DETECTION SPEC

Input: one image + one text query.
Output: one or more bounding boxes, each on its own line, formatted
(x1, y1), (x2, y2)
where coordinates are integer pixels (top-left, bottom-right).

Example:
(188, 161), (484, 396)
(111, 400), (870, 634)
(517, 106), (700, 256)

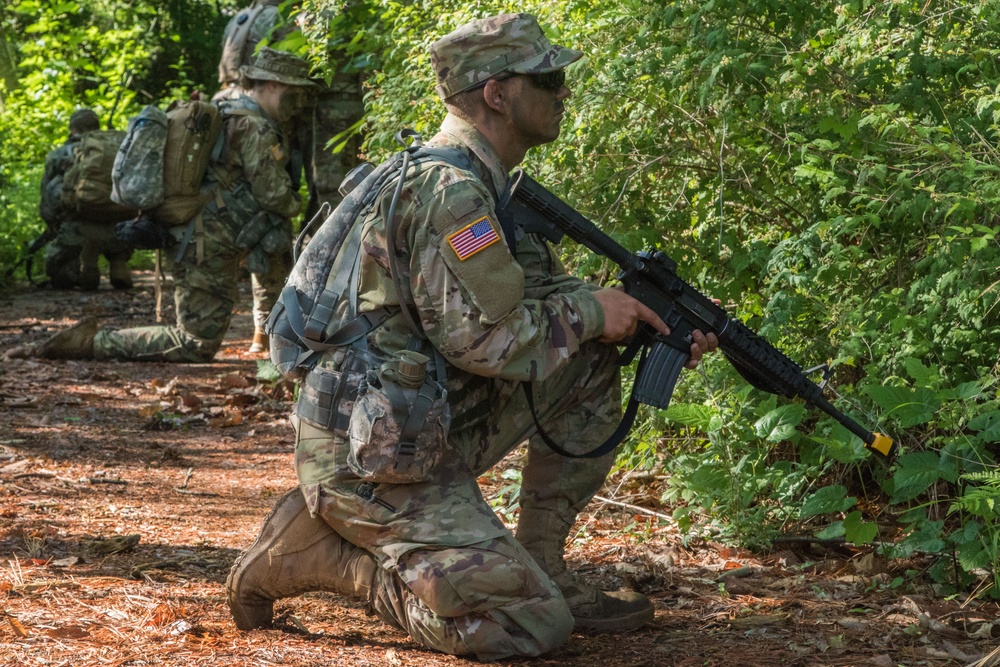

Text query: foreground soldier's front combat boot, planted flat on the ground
(517, 507), (653, 632)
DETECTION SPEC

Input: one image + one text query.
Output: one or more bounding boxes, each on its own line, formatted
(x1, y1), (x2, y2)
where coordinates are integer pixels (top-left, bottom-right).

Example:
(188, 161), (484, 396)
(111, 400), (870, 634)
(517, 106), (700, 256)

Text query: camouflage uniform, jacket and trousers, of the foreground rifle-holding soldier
(293, 15), (621, 660)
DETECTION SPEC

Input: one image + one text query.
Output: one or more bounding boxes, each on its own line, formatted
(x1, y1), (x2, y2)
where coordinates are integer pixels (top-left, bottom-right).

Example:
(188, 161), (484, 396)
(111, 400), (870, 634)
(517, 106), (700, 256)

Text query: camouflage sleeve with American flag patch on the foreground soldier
(410, 171), (604, 381)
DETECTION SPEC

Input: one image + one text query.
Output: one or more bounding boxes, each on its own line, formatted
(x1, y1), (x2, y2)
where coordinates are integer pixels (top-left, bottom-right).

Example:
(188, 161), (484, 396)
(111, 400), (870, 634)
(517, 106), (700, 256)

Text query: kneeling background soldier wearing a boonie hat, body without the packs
(39, 48), (314, 363)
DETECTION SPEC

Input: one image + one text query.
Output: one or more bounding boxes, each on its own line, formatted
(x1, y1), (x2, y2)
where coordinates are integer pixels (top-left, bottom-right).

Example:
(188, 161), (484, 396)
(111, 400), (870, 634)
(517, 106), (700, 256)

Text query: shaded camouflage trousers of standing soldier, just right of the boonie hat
(298, 74), (365, 220)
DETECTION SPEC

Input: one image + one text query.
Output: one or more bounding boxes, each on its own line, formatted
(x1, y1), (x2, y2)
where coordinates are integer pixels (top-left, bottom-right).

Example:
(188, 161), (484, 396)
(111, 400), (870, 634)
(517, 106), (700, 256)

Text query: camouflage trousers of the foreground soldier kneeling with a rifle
(293, 342), (621, 660)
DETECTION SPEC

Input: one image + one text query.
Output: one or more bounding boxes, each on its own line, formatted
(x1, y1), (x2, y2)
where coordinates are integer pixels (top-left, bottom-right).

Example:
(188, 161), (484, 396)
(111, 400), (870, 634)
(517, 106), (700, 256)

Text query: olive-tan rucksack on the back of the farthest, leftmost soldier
(62, 130), (136, 223)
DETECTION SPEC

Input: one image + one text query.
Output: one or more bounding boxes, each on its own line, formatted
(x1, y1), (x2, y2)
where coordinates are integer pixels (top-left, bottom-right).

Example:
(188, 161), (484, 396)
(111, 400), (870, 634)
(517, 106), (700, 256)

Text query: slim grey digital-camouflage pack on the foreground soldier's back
(264, 133), (471, 380)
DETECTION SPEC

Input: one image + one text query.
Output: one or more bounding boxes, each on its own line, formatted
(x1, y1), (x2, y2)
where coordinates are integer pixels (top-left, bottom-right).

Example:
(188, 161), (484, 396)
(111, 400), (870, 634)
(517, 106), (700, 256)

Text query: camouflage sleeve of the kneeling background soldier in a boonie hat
(234, 116), (302, 218)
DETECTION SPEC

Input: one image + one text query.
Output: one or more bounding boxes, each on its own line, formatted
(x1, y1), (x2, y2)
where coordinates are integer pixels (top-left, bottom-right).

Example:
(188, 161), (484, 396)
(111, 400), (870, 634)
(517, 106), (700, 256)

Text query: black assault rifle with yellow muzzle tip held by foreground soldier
(500, 170), (896, 460)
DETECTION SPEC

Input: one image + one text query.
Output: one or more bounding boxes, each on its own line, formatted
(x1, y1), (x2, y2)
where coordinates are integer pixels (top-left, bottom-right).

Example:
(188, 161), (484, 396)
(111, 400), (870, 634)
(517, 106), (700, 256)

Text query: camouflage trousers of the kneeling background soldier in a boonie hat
(94, 211), (244, 363)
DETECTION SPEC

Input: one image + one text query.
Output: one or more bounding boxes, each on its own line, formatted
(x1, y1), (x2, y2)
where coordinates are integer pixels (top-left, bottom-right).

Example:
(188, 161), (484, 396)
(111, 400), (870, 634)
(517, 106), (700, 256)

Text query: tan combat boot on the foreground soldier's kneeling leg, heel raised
(226, 488), (377, 630)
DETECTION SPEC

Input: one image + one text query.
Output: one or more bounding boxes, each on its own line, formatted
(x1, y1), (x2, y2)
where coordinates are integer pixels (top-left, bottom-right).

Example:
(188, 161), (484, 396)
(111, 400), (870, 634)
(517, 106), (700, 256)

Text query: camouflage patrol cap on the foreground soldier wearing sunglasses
(431, 13), (583, 100)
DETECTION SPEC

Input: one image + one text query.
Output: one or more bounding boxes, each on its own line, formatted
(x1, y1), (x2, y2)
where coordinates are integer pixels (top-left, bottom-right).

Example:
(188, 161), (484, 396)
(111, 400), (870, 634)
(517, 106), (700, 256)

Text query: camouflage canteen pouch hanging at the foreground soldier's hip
(347, 358), (451, 484)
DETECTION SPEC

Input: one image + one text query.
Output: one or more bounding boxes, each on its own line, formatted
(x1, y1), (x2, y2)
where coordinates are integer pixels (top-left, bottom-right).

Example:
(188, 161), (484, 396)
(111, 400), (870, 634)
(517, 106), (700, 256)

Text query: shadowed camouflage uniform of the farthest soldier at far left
(39, 109), (132, 289)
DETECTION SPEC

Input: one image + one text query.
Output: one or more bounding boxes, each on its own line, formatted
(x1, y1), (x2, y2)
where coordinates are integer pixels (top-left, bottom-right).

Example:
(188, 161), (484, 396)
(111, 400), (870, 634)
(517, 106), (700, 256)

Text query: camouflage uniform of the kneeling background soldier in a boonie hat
(94, 91), (301, 363)
